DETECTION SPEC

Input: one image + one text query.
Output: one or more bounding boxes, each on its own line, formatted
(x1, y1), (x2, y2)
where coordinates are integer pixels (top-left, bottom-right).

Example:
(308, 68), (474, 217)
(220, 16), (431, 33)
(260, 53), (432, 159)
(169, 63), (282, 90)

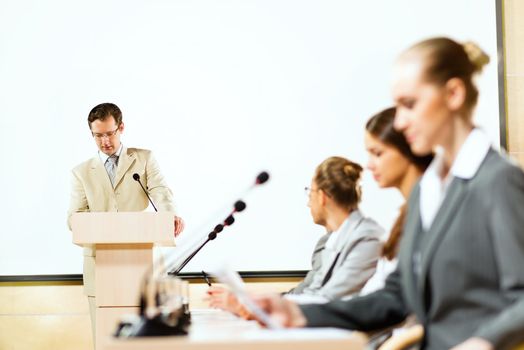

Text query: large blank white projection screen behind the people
(0, 0), (502, 277)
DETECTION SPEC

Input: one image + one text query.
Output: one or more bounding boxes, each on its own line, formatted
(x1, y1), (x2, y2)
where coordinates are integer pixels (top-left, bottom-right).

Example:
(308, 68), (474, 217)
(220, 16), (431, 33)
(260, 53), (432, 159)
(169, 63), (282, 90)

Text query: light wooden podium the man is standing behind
(71, 212), (175, 349)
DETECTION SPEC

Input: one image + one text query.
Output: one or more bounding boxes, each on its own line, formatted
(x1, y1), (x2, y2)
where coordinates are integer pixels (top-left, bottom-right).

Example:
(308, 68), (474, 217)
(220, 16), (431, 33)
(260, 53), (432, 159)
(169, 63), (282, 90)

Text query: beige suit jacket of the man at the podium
(68, 147), (175, 296)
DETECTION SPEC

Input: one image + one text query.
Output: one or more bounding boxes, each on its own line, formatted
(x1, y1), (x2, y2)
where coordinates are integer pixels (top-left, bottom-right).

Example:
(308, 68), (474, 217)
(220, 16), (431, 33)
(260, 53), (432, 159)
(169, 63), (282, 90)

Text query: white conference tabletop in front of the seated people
(98, 309), (367, 350)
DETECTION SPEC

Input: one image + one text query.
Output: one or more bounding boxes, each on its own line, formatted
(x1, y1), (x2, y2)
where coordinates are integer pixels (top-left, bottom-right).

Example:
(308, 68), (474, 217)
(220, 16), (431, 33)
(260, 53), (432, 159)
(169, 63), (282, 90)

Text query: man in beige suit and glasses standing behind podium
(68, 103), (184, 342)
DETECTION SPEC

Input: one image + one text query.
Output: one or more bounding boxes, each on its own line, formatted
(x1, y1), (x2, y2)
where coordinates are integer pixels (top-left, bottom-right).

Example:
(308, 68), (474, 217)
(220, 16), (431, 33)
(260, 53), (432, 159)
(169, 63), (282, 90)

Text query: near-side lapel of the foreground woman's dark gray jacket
(419, 177), (467, 295)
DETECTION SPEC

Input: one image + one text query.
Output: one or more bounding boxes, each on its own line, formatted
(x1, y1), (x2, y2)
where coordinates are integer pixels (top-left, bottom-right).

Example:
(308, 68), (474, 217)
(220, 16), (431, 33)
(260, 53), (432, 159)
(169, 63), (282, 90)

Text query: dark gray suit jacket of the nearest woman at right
(302, 150), (524, 349)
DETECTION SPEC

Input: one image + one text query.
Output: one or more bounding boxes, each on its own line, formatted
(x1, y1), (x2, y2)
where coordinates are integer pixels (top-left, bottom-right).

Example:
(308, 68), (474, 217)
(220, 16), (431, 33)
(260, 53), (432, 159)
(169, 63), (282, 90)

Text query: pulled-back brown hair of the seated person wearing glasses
(313, 157), (362, 210)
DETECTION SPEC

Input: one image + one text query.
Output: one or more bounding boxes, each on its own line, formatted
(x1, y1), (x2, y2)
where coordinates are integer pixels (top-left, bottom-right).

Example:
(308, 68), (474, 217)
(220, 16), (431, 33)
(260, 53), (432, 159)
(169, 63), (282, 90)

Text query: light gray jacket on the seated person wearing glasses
(291, 210), (384, 299)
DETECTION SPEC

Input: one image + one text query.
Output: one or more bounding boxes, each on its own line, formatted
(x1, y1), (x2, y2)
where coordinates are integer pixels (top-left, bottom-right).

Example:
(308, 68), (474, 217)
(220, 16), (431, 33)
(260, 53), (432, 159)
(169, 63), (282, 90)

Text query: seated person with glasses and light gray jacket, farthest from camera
(208, 157), (384, 317)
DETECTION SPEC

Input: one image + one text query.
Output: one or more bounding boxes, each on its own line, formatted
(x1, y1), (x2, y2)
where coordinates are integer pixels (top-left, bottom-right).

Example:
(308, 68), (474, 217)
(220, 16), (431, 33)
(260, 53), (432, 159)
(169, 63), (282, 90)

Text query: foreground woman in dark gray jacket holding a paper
(260, 38), (524, 350)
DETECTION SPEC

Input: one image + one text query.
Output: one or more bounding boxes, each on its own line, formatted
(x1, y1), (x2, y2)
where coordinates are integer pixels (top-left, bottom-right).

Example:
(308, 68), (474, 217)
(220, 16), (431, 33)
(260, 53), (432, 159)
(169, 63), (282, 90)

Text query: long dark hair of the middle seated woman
(366, 107), (433, 260)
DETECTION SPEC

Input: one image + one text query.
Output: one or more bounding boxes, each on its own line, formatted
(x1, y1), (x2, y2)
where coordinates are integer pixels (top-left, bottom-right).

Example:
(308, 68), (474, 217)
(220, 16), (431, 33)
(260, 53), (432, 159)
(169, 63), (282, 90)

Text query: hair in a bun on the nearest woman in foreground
(401, 38), (489, 109)
